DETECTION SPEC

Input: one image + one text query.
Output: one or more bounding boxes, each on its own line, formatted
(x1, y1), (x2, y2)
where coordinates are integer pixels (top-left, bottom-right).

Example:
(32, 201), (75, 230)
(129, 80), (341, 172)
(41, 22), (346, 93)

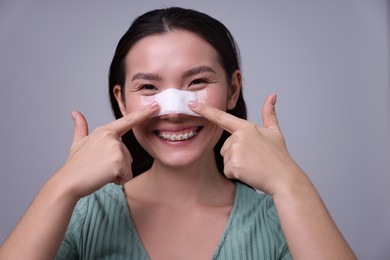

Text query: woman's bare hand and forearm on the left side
(0, 103), (158, 260)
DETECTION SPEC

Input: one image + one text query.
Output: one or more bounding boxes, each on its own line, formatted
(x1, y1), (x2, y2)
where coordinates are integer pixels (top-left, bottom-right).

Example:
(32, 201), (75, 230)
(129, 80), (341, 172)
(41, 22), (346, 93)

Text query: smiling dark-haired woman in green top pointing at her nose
(0, 8), (355, 259)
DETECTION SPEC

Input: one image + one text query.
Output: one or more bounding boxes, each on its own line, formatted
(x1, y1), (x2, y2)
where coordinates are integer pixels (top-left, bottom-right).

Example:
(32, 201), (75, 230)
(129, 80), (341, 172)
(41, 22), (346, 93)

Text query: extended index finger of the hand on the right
(189, 103), (246, 134)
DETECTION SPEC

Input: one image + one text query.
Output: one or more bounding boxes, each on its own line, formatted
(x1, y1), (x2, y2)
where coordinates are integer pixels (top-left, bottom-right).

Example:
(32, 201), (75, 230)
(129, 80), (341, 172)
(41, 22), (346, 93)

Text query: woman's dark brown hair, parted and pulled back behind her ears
(109, 7), (247, 176)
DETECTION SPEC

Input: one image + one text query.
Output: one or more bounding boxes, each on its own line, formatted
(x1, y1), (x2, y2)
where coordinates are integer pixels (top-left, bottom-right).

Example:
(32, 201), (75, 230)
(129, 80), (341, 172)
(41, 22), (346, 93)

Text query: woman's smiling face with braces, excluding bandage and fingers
(114, 30), (241, 167)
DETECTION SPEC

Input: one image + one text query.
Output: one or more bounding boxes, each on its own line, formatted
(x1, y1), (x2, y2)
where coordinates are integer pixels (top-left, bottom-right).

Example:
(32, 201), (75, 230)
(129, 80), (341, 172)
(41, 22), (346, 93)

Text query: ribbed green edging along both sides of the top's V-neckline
(121, 182), (240, 259)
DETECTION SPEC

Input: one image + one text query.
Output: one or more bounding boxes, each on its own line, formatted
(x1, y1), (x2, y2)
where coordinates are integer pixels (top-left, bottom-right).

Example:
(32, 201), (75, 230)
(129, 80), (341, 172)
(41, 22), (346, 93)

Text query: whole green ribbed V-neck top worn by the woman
(56, 182), (291, 260)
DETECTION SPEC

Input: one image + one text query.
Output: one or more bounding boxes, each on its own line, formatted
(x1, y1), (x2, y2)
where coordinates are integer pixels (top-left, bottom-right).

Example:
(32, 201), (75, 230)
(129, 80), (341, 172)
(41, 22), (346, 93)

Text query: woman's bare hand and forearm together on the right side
(189, 95), (356, 259)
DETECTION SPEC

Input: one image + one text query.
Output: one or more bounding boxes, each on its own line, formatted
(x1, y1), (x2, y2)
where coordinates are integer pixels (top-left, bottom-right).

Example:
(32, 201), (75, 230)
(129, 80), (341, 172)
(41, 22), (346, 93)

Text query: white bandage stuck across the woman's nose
(141, 88), (207, 116)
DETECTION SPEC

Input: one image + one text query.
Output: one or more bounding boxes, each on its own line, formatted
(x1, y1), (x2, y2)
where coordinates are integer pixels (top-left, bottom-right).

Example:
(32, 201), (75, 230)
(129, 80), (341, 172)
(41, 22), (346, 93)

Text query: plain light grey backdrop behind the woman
(0, 0), (390, 259)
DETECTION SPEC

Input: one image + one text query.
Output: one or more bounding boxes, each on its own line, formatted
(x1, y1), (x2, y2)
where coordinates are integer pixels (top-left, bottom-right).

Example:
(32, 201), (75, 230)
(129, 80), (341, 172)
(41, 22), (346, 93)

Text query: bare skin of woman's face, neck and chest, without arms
(114, 31), (241, 259)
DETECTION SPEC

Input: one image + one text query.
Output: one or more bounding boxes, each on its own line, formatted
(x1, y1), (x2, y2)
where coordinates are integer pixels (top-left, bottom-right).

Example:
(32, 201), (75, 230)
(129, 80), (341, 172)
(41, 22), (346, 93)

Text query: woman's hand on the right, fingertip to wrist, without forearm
(190, 95), (300, 194)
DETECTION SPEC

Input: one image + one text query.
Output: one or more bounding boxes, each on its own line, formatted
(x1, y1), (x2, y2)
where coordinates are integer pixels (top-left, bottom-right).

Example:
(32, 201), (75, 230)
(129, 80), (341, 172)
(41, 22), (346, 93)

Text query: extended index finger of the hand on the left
(106, 102), (158, 136)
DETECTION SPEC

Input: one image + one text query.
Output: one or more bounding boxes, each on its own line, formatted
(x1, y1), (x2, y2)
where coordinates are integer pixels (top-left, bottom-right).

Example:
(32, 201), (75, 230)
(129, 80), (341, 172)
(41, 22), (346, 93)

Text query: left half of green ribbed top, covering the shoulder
(58, 184), (145, 259)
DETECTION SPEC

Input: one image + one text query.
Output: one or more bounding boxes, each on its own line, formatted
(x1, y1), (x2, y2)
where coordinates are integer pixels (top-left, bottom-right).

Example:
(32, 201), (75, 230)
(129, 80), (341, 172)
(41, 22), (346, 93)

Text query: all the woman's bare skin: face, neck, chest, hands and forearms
(0, 31), (355, 259)
